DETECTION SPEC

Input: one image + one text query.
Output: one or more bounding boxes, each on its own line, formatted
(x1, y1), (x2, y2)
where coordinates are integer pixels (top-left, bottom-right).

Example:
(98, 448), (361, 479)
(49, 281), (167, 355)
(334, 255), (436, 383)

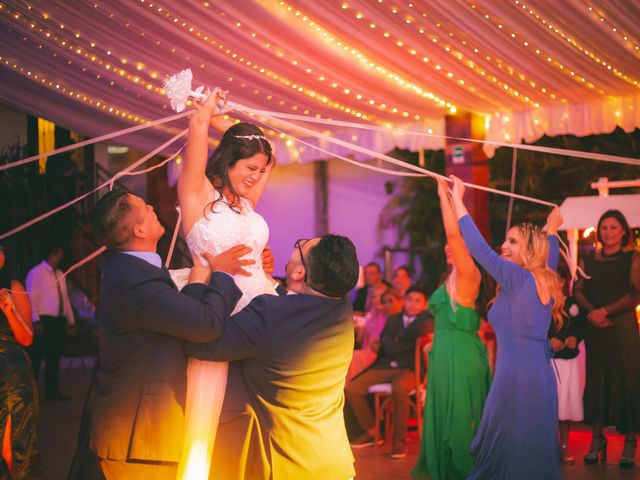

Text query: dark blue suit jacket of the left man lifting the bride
(90, 253), (242, 462)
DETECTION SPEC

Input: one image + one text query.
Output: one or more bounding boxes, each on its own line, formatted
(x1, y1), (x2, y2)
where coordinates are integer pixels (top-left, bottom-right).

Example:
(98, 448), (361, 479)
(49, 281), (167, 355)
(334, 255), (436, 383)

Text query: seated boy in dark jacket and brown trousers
(345, 287), (433, 459)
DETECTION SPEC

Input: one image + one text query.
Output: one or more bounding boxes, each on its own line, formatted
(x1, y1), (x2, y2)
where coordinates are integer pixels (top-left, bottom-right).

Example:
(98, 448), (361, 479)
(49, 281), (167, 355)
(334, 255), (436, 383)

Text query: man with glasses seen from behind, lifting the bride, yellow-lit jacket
(188, 235), (358, 480)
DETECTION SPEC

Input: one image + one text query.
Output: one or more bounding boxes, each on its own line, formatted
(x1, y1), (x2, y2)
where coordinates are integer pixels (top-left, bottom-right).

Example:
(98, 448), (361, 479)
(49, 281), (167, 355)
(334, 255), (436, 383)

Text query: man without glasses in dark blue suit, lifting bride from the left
(90, 191), (250, 480)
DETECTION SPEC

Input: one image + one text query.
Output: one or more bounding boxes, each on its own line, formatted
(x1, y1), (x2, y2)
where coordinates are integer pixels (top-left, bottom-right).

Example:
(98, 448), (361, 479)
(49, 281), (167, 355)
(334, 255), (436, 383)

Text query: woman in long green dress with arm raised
(411, 179), (491, 480)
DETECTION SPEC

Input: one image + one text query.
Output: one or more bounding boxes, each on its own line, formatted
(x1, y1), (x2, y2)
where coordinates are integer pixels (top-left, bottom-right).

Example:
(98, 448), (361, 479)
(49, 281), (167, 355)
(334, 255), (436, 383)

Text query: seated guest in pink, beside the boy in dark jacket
(347, 283), (389, 385)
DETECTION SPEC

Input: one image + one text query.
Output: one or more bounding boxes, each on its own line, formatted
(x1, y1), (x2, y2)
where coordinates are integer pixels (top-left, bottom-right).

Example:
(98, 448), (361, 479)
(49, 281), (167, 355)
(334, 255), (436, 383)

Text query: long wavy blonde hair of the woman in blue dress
(514, 223), (566, 329)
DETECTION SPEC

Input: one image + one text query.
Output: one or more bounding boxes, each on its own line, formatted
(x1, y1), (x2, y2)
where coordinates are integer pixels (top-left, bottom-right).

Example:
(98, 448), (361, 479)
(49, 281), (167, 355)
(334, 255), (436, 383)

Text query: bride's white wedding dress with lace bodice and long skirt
(172, 197), (276, 480)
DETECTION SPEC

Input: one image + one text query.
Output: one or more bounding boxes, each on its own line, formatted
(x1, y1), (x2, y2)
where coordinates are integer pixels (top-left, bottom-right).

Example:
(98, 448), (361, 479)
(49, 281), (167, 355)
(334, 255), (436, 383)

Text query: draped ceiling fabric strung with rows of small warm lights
(0, 0), (640, 163)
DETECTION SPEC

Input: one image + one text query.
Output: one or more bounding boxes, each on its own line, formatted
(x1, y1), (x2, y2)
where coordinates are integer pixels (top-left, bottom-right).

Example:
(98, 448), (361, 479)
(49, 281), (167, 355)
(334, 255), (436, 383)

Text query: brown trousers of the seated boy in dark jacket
(345, 368), (416, 443)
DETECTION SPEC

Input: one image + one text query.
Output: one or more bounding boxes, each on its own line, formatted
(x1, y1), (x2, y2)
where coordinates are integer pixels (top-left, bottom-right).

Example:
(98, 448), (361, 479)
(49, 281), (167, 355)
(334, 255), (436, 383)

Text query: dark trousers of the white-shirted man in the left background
(28, 315), (67, 395)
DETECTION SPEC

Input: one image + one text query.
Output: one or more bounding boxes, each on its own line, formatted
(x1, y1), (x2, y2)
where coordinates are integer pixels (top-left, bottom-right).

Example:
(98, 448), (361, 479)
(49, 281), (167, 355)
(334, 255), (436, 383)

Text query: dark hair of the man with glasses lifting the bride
(307, 235), (360, 298)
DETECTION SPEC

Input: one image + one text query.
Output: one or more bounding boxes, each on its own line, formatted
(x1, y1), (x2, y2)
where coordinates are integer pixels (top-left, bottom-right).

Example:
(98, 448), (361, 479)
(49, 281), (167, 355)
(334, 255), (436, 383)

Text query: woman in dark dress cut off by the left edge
(0, 247), (43, 480)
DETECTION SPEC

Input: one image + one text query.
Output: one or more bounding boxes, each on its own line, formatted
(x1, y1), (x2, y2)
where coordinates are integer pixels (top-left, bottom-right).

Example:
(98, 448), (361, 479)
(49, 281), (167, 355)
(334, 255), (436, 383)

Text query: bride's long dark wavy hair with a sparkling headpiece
(205, 122), (276, 215)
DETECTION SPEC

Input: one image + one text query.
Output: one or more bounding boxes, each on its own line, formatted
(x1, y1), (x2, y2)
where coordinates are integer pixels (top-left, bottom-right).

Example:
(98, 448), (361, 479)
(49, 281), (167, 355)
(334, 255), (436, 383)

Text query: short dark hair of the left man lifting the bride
(91, 190), (131, 250)
